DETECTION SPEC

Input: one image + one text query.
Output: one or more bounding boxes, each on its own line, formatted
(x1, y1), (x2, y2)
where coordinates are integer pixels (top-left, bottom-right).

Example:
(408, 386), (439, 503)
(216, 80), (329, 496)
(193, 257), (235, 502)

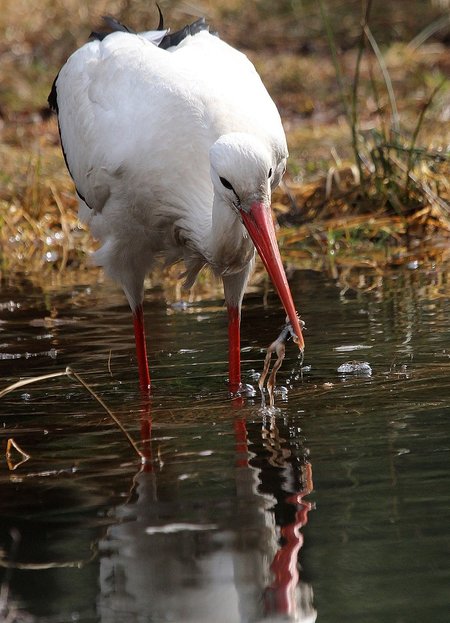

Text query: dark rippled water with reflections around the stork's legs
(0, 270), (450, 623)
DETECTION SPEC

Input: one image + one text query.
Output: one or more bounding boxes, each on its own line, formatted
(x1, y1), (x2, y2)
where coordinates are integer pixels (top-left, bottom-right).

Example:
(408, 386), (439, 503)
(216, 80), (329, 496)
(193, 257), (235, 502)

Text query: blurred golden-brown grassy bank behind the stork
(0, 0), (450, 286)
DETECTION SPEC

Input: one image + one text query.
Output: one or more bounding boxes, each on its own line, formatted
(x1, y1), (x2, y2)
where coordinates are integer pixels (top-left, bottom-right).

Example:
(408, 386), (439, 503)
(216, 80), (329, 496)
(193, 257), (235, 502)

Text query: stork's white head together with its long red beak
(210, 132), (304, 350)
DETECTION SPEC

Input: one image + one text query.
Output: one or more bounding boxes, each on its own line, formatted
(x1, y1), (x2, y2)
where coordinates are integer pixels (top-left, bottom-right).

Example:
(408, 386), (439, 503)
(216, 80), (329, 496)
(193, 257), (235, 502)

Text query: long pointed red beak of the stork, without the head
(241, 201), (305, 351)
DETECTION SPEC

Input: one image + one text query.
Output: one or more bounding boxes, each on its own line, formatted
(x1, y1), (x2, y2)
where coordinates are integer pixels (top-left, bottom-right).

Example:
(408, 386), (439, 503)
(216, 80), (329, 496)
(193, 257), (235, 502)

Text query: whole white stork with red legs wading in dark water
(49, 12), (304, 393)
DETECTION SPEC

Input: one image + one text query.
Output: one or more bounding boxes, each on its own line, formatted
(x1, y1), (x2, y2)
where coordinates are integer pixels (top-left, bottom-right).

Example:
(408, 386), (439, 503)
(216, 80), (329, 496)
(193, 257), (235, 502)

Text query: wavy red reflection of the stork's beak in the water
(265, 463), (313, 615)
